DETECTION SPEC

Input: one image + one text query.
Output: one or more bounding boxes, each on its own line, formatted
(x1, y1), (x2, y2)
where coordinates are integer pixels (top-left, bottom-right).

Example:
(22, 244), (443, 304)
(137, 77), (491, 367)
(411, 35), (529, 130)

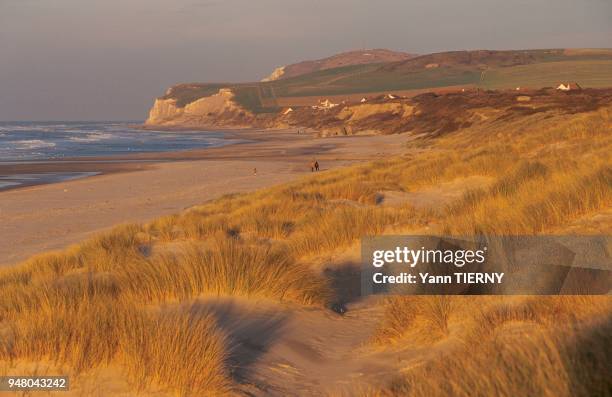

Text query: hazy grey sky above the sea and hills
(0, 0), (612, 120)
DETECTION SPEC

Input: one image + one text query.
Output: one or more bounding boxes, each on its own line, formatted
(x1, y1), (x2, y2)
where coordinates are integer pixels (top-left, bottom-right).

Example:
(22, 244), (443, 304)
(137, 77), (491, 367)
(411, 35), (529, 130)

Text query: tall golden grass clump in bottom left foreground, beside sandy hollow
(0, 273), (232, 395)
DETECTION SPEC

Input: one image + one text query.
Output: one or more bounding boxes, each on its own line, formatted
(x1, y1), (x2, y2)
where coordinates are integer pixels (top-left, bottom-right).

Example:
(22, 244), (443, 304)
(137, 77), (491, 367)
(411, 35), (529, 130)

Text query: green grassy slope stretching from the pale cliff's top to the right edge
(165, 50), (612, 113)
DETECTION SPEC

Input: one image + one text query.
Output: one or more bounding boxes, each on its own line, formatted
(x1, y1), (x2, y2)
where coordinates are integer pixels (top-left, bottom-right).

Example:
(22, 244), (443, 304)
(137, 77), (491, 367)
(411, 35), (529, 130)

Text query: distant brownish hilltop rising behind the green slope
(262, 48), (414, 81)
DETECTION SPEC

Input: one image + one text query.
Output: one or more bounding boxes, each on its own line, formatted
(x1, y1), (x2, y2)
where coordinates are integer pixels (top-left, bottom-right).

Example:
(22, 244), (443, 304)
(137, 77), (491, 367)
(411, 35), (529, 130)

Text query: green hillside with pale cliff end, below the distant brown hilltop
(147, 49), (612, 126)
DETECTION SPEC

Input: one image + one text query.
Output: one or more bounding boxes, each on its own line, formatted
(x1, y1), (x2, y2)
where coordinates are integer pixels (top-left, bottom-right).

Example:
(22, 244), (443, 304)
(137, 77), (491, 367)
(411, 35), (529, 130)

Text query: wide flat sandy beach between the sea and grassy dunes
(0, 131), (409, 266)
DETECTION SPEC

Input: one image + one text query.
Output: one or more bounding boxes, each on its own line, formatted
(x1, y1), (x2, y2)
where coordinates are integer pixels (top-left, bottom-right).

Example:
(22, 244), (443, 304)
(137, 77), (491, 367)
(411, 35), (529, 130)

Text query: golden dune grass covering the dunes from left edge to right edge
(0, 95), (612, 396)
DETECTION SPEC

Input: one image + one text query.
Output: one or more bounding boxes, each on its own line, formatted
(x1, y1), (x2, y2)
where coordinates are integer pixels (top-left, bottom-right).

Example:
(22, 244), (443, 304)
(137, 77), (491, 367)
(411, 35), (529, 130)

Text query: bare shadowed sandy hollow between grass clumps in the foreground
(194, 297), (414, 396)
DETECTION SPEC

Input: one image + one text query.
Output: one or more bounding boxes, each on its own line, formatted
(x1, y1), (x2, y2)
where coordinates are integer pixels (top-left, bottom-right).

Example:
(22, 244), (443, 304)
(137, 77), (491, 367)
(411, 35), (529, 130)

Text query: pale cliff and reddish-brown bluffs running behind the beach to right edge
(146, 83), (612, 136)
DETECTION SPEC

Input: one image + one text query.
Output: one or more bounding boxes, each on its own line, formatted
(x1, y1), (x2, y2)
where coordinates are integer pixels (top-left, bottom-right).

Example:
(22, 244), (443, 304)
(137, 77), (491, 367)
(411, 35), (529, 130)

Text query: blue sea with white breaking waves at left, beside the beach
(0, 121), (235, 190)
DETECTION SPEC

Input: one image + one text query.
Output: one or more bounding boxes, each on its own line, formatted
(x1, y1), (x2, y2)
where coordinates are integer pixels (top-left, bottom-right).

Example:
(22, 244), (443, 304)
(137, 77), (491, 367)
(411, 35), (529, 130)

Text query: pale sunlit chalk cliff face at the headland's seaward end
(145, 88), (255, 128)
